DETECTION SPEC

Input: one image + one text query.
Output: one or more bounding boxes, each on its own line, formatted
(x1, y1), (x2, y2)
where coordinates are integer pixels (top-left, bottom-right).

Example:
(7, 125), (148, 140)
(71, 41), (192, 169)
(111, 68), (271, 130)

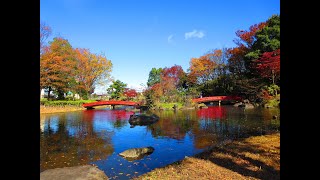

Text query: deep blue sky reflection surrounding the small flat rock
(93, 126), (201, 178)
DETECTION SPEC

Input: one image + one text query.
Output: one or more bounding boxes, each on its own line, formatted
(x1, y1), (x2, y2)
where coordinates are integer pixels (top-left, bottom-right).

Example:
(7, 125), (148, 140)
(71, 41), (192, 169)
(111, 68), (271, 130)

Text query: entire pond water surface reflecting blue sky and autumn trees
(40, 106), (280, 179)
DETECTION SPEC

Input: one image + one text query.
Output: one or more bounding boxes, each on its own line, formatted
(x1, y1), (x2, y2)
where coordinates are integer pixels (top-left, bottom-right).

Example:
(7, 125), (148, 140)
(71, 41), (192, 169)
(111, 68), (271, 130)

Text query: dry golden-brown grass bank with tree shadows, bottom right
(135, 133), (280, 179)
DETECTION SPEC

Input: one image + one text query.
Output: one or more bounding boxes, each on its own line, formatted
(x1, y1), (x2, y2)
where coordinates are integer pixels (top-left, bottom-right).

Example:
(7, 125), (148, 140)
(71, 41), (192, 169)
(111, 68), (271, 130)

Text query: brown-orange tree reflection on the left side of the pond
(40, 112), (114, 171)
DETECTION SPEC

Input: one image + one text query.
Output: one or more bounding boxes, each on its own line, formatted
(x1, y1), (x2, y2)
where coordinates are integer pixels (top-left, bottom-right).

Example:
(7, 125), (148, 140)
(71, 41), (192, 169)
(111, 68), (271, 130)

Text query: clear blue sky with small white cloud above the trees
(40, 0), (280, 93)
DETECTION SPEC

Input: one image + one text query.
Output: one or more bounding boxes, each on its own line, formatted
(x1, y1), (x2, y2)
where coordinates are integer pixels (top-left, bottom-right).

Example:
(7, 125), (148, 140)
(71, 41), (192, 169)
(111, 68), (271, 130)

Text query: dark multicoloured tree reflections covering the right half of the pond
(147, 106), (279, 149)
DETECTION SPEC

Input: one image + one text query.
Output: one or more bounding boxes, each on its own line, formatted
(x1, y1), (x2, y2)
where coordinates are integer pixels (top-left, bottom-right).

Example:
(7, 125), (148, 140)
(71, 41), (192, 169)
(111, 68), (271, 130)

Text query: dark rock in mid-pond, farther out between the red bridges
(129, 114), (159, 126)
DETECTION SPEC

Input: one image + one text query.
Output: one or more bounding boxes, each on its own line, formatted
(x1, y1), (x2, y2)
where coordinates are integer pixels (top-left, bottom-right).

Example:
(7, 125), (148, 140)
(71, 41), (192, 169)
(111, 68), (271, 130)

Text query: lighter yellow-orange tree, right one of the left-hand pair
(74, 48), (112, 97)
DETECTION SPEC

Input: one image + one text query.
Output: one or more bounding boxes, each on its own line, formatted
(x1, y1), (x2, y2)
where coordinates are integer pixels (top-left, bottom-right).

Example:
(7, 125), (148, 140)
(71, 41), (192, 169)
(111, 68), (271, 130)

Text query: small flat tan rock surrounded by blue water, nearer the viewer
(119, 146), (154, 160)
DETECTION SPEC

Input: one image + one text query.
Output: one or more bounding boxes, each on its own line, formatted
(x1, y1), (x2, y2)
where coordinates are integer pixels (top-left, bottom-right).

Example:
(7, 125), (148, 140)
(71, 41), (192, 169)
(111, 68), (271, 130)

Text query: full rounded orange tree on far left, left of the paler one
(40, 37), (76, 99)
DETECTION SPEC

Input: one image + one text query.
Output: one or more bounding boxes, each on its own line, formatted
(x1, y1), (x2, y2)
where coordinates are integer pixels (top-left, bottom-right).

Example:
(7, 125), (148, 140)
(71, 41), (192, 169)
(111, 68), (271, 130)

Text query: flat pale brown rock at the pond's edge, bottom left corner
(40, 165), (109, 180)
